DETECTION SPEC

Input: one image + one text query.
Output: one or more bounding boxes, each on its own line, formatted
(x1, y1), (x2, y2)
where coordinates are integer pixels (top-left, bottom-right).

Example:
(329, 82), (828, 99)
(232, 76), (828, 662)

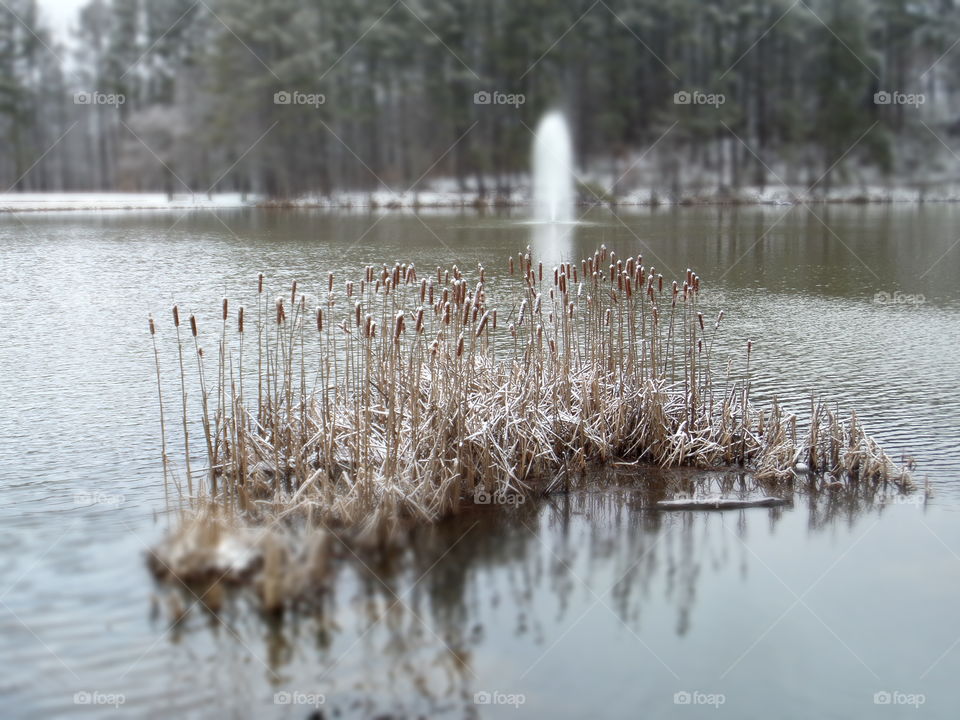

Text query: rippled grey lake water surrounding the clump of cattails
(0, 204), (960, 719)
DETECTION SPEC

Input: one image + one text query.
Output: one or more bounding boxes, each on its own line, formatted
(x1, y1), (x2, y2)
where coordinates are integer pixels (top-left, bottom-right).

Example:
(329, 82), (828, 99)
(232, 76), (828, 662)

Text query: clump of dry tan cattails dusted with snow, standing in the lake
(148, 247), (910, 580)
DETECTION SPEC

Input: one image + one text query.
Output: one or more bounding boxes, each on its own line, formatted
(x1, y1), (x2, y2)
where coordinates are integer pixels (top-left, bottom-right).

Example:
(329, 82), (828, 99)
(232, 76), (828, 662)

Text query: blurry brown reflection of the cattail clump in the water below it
(154, 471), (922, 717)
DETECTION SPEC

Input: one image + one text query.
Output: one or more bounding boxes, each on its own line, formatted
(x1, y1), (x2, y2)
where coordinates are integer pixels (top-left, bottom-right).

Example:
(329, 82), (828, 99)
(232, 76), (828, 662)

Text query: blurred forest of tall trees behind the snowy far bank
(0, 0), (960, 198)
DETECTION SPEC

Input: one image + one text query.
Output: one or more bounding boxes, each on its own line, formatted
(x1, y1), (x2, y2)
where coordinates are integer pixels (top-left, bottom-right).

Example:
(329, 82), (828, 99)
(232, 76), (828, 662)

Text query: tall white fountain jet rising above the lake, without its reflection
(533, 110), (573, 223)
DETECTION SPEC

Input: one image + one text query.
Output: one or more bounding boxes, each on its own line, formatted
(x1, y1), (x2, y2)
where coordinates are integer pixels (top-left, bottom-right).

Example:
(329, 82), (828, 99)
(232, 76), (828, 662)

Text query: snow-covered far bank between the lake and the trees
(0, 184), (960, 213)
